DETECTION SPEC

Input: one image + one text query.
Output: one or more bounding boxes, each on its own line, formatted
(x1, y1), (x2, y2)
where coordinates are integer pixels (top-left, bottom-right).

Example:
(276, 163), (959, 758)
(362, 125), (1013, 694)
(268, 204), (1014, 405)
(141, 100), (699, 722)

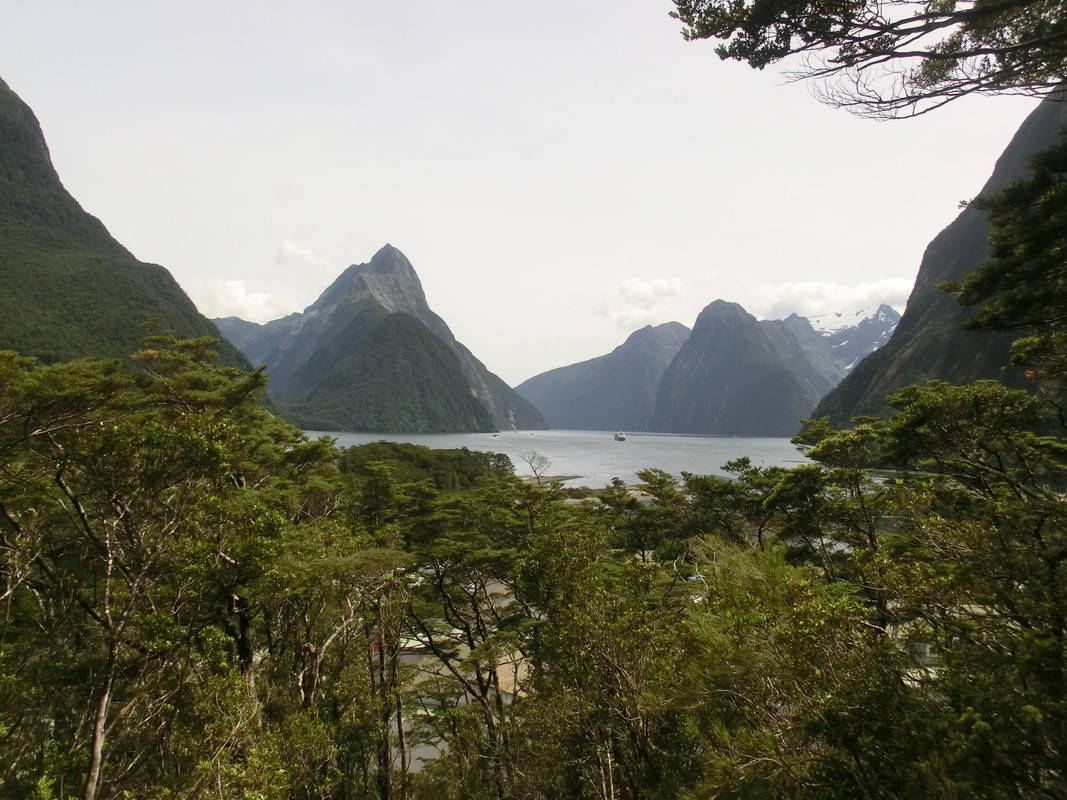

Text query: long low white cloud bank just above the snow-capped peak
(742, 278), (914, 319)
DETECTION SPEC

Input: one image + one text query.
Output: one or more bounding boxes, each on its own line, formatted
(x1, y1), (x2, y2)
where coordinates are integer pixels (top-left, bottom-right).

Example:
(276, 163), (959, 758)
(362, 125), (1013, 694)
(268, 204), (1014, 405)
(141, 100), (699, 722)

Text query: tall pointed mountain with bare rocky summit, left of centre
(216, 244), (546, 432)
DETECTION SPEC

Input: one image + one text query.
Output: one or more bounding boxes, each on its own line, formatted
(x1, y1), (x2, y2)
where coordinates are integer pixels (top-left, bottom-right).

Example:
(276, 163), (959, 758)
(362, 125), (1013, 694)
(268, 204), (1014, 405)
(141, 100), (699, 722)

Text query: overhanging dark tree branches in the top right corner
(672, 0), (1067, 117)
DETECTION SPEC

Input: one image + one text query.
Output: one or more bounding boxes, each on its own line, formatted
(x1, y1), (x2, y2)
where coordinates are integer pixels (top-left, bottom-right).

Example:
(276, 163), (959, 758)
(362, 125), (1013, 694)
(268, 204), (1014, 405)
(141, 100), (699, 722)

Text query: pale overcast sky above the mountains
(0, 0), (1037, 386)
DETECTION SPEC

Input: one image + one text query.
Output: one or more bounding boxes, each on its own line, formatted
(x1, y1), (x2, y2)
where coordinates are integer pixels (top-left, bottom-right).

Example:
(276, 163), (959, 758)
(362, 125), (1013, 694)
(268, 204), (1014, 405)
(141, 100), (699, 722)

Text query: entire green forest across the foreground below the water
(6, 332), (1067, 800)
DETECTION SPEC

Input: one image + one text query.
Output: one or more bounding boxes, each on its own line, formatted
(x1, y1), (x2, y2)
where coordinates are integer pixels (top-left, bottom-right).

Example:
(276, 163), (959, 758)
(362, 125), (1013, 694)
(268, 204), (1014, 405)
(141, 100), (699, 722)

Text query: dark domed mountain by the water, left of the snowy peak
(649, 300), (843, 436)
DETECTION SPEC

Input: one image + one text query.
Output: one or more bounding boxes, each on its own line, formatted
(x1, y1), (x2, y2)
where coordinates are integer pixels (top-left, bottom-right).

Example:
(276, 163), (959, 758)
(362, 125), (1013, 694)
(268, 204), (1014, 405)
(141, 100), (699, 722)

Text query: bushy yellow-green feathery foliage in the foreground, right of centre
(688, 543), (921, 798)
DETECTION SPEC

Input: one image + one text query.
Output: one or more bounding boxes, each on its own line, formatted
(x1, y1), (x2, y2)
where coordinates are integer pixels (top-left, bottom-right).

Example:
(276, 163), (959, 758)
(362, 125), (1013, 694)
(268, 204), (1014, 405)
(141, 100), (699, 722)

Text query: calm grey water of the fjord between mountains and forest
(307, 431), (805, 489)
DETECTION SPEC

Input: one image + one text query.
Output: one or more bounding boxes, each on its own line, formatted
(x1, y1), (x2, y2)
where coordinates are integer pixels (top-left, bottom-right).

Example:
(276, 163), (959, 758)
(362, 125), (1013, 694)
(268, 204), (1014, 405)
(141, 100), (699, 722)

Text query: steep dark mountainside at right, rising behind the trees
(814, 93), (1067, 426)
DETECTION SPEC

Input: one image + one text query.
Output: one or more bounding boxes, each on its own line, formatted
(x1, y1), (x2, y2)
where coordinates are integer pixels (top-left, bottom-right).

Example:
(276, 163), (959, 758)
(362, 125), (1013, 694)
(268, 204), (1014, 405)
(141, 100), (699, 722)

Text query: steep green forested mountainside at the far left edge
(0, 73), (248, 367)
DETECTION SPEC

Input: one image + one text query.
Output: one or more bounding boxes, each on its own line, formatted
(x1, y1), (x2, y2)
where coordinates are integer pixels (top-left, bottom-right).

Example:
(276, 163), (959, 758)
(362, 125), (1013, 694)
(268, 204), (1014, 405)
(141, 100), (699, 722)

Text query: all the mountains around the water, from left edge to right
(0, 66), (1067, 436)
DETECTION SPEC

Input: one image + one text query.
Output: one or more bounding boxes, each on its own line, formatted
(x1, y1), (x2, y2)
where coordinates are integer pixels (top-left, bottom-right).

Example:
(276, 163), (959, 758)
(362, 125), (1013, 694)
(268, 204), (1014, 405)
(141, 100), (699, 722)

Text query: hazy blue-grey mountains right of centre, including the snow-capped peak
(516, 300), (901, 436)
